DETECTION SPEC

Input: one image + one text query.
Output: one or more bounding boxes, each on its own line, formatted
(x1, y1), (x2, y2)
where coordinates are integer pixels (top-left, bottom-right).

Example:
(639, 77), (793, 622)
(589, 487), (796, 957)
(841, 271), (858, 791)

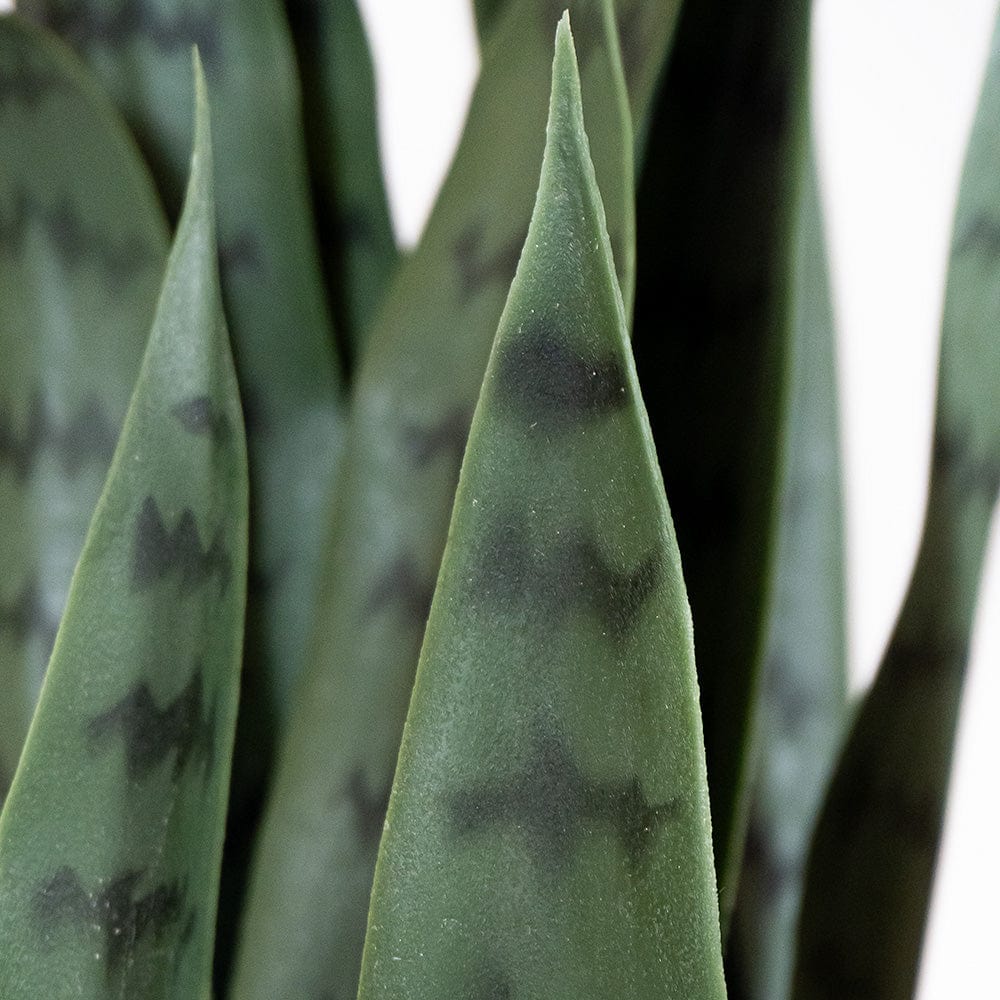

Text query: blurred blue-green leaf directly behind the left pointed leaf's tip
(18, 0), (342, 740)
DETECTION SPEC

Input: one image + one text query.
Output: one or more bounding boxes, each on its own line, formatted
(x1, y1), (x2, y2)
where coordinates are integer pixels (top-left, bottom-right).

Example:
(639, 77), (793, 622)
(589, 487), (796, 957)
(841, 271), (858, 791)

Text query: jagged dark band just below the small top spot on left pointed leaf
(132, 496), (232, 590)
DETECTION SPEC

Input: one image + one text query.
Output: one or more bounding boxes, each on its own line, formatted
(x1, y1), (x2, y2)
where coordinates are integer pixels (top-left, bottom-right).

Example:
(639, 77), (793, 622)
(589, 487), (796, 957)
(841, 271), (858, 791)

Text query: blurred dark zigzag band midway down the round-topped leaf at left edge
(0, 391), (118, 482)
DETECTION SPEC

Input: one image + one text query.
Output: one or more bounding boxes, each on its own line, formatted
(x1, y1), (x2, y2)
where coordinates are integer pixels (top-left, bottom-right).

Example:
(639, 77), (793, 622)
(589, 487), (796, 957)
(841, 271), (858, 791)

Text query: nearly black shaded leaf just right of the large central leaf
(635, 0), (810, 920)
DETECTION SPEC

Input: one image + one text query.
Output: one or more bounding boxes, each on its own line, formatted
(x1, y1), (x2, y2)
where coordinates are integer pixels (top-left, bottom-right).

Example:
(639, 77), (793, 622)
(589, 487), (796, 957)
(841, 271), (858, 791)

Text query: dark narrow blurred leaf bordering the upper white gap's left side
(285, 0), (399, 357)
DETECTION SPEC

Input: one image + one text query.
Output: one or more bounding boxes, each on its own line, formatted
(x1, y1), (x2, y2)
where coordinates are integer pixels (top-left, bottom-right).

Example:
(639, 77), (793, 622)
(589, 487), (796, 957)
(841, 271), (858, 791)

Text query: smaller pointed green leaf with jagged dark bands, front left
(0, 58), (247, 1000)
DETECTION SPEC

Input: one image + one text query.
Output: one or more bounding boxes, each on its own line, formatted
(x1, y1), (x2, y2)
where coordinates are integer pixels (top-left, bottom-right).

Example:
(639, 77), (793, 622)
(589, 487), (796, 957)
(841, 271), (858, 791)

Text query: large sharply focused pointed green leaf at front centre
(359, 17), (725, 1000)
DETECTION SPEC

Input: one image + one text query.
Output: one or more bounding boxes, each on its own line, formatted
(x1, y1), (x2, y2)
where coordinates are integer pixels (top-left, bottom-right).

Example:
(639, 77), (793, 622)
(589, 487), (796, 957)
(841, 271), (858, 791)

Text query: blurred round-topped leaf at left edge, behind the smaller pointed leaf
(0, 16), (168, 802)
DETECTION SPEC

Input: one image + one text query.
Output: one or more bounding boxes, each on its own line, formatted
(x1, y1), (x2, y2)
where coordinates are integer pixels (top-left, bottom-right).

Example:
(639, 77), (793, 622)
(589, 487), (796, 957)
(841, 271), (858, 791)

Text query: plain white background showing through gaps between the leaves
(0, 0), (1000, 1000)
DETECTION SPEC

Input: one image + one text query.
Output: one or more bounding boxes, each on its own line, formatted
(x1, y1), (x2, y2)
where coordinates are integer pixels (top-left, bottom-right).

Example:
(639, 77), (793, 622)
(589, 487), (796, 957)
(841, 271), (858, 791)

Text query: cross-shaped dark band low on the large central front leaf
(446, 728), (679, 872)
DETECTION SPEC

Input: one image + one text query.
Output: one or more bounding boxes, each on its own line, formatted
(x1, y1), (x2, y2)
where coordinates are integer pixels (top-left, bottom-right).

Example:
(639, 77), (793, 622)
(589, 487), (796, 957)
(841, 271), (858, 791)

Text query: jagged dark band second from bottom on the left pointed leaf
(87, 666), (215, 781)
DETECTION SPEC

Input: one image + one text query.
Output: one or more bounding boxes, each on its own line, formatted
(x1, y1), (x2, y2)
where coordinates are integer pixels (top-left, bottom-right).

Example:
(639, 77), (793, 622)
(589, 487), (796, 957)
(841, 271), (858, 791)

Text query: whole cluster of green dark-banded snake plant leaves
(0, 0), (1000, 1000)
